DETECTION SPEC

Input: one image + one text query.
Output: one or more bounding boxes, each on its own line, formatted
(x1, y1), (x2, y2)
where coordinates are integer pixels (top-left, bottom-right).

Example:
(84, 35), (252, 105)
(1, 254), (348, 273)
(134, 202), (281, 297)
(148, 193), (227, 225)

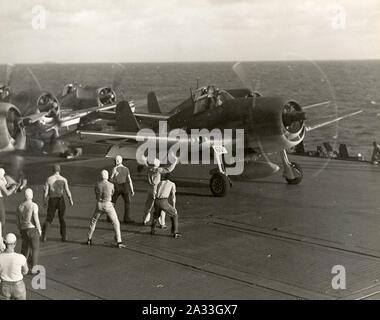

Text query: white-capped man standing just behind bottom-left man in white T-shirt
(17, 188), (42, 272)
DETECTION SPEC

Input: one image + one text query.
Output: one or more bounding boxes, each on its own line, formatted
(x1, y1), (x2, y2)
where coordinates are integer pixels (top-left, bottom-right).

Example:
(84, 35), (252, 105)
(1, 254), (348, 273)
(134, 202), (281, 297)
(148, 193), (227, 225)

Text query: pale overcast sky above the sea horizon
(0, 0), (380, 63)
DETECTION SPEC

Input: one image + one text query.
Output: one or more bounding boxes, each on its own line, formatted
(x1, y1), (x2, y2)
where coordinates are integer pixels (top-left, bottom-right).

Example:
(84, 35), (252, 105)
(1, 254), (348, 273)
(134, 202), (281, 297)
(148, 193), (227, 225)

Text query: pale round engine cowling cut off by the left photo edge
(0, 103), (26, 152)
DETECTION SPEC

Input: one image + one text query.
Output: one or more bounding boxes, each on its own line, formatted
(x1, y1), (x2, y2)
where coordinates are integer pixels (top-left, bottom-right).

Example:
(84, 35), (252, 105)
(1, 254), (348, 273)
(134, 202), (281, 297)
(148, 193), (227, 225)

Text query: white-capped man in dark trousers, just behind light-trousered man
(111, 155), (135, 223)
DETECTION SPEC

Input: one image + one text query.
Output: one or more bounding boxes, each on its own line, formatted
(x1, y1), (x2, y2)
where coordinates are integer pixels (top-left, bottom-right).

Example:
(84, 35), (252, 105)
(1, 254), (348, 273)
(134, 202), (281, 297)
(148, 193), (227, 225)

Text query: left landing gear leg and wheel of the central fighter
(210, 146), (232, 197)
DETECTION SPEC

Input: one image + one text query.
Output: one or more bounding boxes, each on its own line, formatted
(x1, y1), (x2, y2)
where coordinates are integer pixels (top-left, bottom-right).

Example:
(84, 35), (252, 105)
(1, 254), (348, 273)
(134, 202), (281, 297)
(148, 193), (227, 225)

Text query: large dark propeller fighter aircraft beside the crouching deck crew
(75, 81), (361, 196)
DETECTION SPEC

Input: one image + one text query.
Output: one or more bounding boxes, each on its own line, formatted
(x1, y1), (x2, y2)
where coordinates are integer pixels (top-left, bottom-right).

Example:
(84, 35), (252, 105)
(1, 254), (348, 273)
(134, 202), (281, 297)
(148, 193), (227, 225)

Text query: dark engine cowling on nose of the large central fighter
(246, 97), (306, 152)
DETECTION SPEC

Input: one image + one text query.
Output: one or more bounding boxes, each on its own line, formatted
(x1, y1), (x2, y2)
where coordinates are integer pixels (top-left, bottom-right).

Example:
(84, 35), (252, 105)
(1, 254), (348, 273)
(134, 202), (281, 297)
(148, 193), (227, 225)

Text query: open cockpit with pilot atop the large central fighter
(193, 85), (234, 114)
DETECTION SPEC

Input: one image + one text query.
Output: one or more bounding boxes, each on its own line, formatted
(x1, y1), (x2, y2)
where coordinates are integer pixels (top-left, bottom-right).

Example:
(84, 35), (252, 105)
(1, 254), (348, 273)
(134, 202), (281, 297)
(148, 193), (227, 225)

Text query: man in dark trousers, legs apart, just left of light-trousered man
(42, 164), (74, 241)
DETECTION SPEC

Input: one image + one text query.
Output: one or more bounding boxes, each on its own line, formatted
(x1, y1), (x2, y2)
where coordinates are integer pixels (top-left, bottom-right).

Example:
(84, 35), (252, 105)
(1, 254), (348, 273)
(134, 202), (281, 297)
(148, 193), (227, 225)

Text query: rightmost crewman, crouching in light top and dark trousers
(151, 175), (181, 238)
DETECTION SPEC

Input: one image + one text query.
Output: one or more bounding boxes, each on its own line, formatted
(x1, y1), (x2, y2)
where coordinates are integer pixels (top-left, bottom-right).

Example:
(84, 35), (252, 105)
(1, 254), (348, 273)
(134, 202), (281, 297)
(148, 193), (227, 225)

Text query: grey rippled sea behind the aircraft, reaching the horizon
(0, 60), (380, 158)
